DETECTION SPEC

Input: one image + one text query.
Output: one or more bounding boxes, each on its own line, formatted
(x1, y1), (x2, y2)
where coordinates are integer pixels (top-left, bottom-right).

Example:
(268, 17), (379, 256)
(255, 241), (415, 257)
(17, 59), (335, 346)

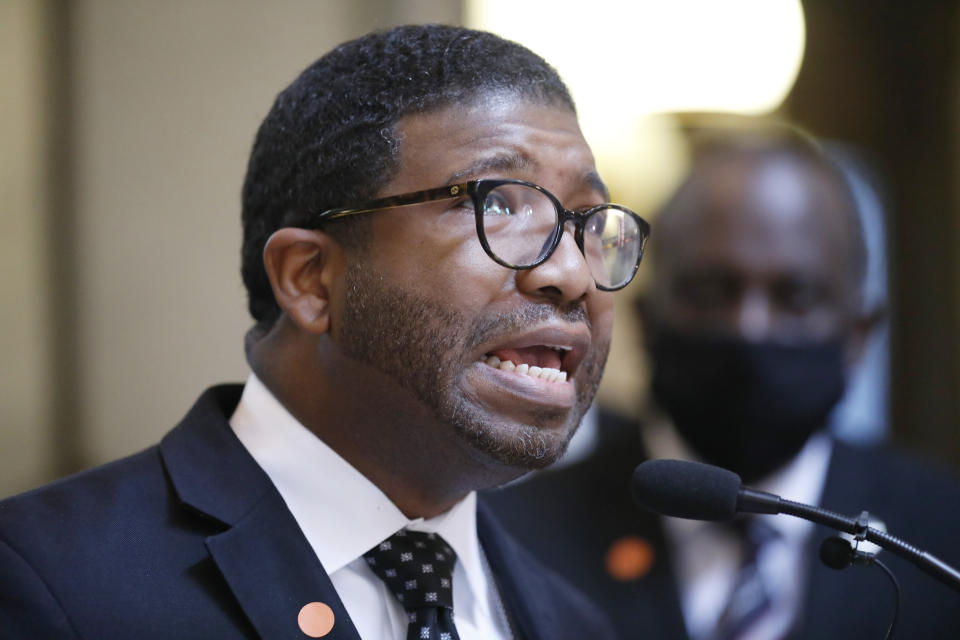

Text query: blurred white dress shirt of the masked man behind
(644, 421), (833, 640)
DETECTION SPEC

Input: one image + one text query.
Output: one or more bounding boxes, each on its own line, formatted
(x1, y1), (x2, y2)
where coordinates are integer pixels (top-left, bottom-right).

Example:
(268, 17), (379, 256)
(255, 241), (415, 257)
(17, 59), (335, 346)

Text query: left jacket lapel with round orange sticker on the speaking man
(160, 385), (360, 640)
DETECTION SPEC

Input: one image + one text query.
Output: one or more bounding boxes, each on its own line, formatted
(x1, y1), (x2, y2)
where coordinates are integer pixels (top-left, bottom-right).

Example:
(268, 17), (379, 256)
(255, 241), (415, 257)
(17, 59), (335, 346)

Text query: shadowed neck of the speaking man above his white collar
(250, 320), (523, 518)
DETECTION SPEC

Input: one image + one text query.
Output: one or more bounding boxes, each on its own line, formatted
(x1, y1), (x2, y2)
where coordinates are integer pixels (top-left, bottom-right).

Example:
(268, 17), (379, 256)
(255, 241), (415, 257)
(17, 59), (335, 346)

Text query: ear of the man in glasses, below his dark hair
(263, 227), (344, 334)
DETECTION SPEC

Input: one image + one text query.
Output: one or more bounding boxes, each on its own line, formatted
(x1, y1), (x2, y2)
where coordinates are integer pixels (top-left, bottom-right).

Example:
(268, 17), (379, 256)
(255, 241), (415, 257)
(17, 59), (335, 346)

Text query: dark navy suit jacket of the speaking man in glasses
(0, 385), (613, 640)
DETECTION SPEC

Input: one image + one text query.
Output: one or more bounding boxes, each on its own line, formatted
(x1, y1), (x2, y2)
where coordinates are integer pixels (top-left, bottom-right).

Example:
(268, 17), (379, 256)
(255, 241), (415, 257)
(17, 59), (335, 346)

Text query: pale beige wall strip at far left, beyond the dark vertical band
(0, 0), (53, 494)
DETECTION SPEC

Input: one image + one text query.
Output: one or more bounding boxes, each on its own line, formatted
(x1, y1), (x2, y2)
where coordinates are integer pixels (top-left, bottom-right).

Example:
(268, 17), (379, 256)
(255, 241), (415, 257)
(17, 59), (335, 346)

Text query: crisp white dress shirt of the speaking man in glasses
(230, 374), (511, 640)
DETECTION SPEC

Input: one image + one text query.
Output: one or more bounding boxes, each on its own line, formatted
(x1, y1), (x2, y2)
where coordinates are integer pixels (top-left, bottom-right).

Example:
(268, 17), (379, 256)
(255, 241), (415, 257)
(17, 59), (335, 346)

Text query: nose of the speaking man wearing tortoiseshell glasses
(517, 222), (597, 304)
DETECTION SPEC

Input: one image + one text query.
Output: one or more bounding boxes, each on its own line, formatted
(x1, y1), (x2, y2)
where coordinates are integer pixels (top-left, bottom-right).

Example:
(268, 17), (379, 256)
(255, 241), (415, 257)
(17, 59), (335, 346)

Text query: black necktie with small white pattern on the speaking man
(363, 529), (459, 640)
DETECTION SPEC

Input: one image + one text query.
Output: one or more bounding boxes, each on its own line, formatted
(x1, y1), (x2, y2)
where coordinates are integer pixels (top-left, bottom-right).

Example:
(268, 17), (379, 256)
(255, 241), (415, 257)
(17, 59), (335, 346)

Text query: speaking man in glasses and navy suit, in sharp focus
(0, 26), (648, 640)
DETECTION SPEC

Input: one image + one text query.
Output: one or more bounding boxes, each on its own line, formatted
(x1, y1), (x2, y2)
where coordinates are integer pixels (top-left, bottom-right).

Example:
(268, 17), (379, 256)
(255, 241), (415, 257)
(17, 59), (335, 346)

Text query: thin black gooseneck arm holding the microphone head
(737, 487), (960, 591)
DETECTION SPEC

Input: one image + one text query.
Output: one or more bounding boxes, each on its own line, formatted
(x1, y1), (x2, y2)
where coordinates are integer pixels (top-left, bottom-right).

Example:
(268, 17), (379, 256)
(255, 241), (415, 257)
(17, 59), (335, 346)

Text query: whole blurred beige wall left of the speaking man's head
(0, 0), (460, 495)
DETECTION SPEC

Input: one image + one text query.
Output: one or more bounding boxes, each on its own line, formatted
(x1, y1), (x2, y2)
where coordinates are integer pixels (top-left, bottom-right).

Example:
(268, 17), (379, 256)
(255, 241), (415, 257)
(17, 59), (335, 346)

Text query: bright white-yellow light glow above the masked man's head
(464, 0), (805, 214)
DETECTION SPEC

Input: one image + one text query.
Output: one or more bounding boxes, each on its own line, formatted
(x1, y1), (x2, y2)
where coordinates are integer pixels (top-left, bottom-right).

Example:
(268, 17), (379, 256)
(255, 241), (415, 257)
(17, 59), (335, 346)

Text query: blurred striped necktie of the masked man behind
(713, 518), (778, 640)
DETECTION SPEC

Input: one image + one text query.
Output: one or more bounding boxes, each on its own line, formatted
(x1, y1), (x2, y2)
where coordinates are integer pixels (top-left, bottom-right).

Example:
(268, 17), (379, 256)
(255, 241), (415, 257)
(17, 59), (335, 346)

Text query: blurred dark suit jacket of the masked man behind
(486, 414), (960, 640)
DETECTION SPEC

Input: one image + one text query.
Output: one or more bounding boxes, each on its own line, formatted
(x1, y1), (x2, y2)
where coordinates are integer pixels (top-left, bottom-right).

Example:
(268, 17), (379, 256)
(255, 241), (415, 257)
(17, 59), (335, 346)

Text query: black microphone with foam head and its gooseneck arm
(630, 459), (960, 591)
